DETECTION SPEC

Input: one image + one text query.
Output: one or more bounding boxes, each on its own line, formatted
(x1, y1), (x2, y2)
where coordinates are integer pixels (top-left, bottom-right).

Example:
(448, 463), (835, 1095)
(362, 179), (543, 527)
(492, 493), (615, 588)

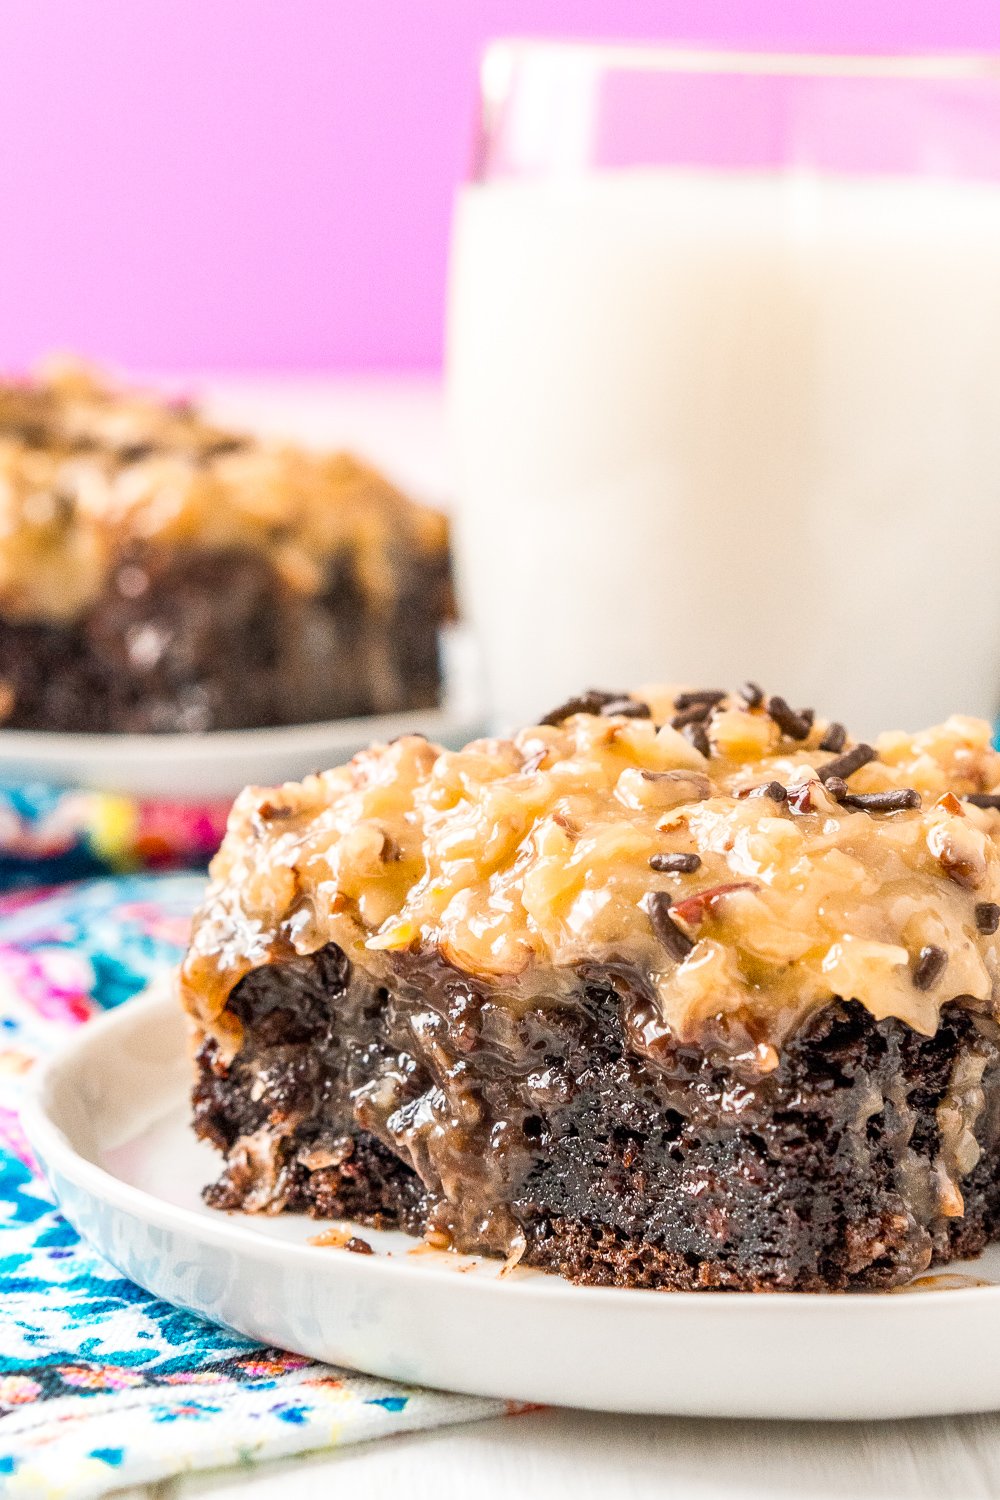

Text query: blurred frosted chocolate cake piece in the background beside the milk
(0, 366), (453, 734)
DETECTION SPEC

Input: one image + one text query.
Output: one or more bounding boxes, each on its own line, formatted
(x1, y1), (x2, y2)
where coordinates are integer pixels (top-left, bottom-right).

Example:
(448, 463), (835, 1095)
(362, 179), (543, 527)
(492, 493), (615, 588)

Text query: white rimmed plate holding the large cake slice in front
(25, 993), (1000, 1419)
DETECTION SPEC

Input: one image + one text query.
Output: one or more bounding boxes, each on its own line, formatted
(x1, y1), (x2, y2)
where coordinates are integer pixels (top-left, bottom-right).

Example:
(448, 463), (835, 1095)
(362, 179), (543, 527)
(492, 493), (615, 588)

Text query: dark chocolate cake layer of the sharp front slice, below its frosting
(195, 945), (1000, 1292)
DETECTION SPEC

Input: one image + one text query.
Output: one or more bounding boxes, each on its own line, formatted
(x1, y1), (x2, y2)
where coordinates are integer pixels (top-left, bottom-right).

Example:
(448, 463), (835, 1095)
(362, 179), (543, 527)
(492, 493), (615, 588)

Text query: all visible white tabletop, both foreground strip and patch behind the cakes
(111, 378), (1000, 1500)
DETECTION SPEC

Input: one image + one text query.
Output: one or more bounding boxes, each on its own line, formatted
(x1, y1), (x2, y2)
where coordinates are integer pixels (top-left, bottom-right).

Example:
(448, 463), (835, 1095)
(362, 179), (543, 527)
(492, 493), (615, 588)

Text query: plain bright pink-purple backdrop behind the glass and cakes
(0, 0), (1000, 371)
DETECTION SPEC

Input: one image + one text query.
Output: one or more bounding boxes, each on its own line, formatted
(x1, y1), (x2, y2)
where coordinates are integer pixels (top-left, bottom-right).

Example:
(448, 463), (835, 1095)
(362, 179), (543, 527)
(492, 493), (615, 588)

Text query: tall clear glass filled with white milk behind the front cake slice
(448, 42), (1000, 734)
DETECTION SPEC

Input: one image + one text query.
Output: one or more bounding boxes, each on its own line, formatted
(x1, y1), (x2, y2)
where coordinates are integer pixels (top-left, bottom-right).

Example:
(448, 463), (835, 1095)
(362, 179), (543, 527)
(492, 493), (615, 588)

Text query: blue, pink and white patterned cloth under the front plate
(0, 875), (522, 1500)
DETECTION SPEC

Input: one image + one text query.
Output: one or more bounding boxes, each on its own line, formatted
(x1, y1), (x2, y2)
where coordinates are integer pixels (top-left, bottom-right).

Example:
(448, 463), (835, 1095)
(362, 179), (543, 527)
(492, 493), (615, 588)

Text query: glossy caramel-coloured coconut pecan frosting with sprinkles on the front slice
(181, 684), (1000, 1071)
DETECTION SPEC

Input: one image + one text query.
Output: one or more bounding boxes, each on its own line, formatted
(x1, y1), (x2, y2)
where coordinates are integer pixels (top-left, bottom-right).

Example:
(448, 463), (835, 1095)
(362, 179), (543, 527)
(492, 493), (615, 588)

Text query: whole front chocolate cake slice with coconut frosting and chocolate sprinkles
(181, 684), (1000, 1292)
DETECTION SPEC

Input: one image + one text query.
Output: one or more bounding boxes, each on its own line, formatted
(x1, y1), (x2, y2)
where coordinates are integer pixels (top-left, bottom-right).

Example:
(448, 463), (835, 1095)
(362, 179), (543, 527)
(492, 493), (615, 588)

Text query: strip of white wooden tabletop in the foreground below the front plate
(115, 1412), (1000, 1500)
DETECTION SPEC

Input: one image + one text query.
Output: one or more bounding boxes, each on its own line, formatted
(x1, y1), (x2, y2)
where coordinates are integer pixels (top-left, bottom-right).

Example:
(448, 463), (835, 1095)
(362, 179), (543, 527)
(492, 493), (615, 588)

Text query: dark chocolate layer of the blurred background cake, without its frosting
(0, 546), (450, 734)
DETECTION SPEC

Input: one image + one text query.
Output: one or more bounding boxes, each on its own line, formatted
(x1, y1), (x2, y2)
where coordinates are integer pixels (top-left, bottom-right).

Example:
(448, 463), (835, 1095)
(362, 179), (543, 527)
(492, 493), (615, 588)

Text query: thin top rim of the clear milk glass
(480, 36), (1000, 85)
